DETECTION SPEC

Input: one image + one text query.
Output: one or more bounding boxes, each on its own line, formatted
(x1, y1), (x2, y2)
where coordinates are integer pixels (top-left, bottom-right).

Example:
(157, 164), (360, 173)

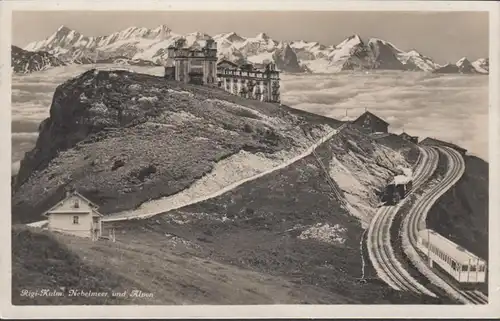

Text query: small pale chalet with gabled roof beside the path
(43, 191), (103, 239)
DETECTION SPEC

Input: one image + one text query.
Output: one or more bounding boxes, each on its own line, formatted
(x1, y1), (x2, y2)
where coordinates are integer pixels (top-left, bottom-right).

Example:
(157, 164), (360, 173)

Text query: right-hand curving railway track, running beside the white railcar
(402, 147), (488, 304)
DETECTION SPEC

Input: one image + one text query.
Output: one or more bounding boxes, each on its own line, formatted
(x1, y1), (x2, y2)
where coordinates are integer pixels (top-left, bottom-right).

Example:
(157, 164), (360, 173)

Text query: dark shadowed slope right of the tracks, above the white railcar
(427, 156), (489, 260)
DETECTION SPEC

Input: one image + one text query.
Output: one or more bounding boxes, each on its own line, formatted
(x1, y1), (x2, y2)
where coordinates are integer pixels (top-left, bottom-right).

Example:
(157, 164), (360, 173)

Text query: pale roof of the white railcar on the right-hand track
(418, 229), (484, 264)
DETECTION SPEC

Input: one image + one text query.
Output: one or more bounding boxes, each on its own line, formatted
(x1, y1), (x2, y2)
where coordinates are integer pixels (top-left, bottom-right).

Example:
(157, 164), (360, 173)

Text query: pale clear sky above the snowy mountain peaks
(12, 11), (489, 63)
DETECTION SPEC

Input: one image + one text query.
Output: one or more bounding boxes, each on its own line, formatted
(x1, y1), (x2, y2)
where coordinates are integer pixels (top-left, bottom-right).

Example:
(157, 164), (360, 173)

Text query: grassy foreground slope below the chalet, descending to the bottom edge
(12, 227), (348, 305)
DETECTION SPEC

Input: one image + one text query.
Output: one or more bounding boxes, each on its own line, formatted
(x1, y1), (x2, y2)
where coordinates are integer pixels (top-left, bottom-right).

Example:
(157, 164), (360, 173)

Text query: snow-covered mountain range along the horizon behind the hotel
(13, 25), (489, 74)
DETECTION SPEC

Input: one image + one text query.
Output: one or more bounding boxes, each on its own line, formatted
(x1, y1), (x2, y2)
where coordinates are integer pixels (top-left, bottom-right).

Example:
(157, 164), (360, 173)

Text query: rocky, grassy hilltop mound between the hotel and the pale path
(12, 70), (341, 222)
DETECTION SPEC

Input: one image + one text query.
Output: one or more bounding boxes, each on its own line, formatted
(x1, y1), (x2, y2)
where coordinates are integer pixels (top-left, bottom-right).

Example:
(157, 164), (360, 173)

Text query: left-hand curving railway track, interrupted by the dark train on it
(367, 148), (438, 296)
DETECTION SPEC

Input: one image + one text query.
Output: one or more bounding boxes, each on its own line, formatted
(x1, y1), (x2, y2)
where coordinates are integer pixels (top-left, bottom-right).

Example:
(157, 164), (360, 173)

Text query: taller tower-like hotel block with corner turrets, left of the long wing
(165, 38), (217, 85)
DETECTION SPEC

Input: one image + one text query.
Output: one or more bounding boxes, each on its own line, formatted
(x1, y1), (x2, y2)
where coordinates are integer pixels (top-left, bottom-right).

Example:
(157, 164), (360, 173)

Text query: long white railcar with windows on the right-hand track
(417, 229), (487, 284)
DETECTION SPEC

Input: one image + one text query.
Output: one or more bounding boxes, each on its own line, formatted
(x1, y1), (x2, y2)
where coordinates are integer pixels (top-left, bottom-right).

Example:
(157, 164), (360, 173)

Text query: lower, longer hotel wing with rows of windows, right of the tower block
(217, 61), (281, 103)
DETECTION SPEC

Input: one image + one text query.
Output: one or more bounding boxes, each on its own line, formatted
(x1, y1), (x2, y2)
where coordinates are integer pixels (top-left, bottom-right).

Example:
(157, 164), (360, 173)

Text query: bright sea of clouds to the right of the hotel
(282, 71), (488, 160)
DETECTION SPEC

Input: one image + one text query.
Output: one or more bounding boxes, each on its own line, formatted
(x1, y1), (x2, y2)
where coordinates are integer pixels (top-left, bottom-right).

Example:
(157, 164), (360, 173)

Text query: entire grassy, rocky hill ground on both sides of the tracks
(12, 67), (488, 304)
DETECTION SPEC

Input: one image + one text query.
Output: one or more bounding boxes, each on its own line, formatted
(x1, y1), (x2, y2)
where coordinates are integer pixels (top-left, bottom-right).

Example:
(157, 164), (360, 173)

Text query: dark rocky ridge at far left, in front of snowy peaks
(11, 46), (65, 74)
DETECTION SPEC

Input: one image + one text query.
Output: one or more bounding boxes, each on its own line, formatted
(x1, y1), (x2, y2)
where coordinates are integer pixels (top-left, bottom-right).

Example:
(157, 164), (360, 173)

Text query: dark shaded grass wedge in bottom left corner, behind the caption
(12, 227), (148, 305)
